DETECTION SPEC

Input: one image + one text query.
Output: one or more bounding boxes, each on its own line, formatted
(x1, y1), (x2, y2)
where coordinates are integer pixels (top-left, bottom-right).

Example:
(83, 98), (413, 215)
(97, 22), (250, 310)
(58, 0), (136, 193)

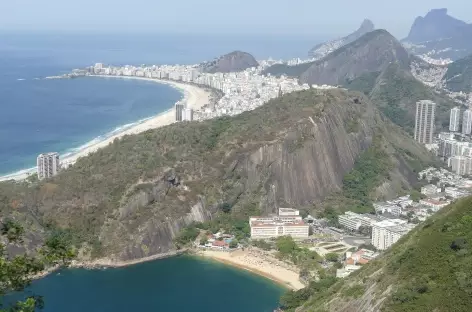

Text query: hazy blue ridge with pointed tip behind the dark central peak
(308, 19), (375, 60)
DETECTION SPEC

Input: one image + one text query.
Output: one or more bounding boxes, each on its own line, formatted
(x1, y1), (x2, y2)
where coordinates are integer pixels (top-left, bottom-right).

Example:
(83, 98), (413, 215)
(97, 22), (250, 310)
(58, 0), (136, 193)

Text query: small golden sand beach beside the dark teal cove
(198, 249), (305, 290)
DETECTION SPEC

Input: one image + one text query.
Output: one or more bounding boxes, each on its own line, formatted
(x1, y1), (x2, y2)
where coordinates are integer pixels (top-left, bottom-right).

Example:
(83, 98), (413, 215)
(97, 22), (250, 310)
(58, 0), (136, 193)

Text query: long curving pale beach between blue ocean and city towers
(0, 76), (210, 181)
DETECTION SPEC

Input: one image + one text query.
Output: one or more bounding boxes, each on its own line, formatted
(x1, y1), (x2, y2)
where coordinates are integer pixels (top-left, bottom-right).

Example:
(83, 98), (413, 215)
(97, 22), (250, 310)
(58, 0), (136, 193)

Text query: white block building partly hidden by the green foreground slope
(372, 219), (414, 250)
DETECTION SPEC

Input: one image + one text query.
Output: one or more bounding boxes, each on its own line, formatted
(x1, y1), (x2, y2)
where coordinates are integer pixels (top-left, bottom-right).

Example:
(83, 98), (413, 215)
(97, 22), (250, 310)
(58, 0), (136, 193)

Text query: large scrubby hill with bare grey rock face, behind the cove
(0, 89), (431, 260)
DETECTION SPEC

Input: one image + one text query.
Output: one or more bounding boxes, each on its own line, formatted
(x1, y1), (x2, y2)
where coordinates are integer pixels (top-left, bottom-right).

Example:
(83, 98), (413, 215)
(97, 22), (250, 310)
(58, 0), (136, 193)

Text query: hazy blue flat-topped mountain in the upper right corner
(402, 9), (472, 61)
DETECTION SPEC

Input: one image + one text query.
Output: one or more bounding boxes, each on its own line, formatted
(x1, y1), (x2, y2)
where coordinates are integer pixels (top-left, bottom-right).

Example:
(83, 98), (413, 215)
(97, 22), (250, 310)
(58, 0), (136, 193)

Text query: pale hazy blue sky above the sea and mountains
(0, 0), (472, 38)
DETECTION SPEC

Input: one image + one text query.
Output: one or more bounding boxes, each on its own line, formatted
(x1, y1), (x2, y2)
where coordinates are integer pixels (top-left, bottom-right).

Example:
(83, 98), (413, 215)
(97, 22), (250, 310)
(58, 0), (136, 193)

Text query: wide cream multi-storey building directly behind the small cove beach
(249, 208), (310, 238)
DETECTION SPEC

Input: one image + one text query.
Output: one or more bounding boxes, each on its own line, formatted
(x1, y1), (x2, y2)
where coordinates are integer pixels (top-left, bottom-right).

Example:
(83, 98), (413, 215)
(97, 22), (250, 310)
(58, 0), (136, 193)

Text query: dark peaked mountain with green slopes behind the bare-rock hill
(265, 30), (454, 133)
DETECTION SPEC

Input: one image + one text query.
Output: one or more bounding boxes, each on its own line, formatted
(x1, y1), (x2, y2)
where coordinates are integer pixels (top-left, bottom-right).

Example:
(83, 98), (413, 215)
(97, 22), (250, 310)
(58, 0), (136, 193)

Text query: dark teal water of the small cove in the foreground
(24, 256), (284, 312)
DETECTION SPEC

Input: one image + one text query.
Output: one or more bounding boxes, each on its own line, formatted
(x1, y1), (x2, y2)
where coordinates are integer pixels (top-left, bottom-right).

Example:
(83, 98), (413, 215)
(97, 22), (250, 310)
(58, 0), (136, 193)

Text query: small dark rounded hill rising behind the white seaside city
(200, 51), (259, 73)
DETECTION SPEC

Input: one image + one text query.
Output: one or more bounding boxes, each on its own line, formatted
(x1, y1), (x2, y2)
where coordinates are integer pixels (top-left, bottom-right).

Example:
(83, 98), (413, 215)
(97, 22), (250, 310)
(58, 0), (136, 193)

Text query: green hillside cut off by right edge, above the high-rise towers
(443, 54), (472, 93)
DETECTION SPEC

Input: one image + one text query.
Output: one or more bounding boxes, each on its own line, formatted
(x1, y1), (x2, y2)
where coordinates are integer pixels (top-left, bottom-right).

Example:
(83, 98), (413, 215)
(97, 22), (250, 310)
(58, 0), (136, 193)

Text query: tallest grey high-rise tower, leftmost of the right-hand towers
(415, 100), (436, 144)
